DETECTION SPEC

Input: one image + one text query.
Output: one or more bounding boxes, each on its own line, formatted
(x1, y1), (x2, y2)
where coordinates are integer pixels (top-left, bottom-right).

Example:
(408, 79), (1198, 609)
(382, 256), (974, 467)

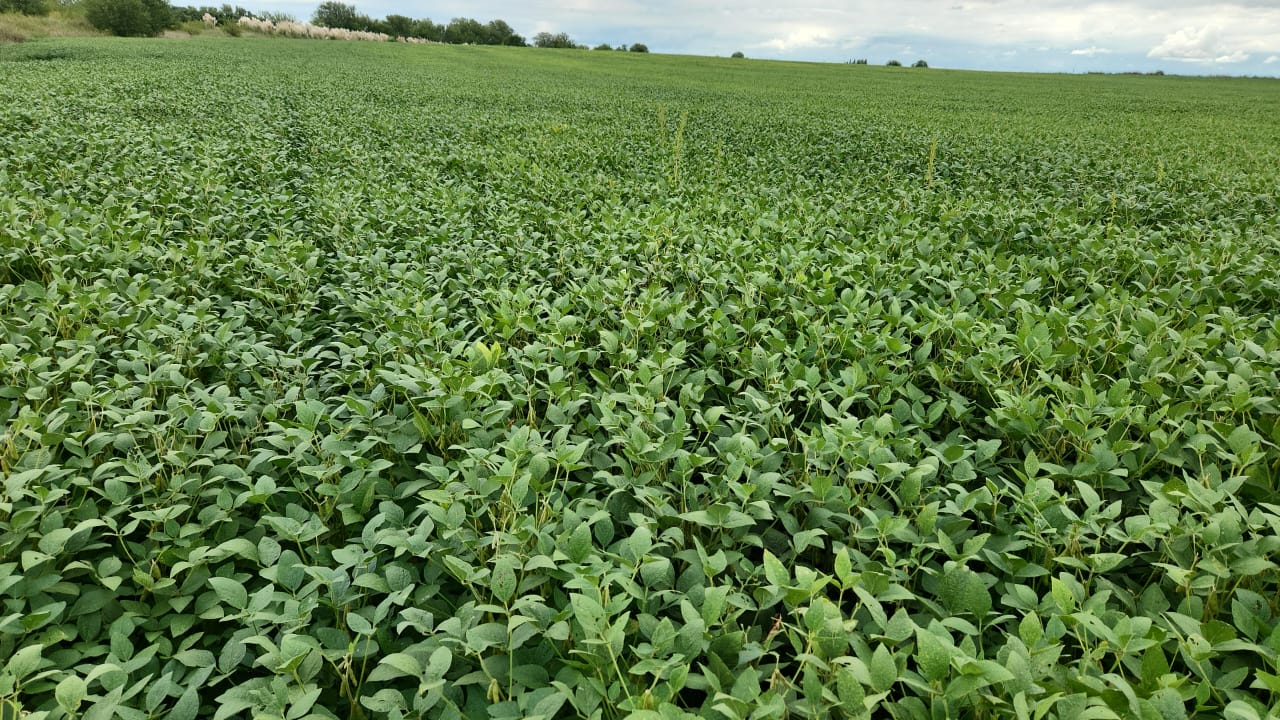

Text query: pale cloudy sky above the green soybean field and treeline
(241, 0), (1280, 77)
